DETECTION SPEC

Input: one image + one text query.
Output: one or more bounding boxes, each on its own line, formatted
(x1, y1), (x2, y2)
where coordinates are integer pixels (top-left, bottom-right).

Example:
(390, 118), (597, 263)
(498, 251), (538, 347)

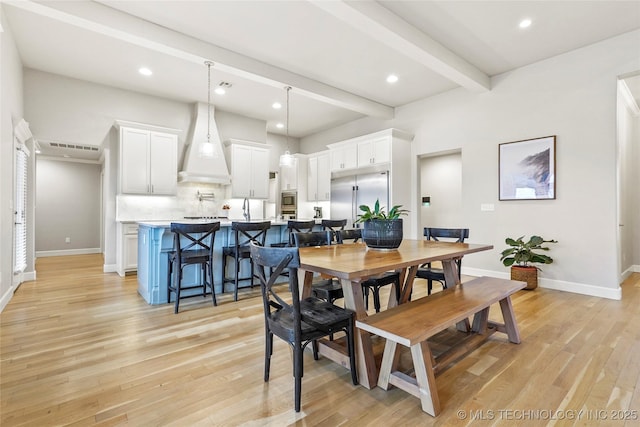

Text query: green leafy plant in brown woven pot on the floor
(500, 236), (558, 290)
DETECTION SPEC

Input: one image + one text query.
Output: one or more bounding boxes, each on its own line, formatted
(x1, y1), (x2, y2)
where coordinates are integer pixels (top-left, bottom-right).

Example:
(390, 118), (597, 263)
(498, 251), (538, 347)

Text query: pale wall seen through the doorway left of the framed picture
(418, 153), (467, 229)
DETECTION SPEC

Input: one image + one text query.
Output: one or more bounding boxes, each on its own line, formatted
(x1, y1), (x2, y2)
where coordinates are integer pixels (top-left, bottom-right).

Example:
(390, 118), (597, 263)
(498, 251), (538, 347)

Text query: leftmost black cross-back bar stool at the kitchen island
(167, 222), (220, 314)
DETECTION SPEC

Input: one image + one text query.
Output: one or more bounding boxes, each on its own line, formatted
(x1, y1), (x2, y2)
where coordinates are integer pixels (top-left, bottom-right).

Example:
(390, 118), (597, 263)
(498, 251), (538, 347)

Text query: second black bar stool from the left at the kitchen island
(222, 221), (271, 301)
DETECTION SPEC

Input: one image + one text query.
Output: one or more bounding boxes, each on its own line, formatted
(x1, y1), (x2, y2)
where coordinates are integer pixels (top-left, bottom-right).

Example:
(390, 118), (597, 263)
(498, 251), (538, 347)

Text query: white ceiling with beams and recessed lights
(2, 0), (640, 160)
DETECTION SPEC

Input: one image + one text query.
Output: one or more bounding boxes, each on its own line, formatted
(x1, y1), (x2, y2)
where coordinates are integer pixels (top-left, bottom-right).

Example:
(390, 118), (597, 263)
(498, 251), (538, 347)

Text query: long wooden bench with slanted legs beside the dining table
(356, 277), (526, 416)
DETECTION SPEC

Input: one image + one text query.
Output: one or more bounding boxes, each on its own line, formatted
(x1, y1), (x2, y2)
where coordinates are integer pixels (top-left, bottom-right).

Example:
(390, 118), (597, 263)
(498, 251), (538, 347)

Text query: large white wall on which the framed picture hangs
(301, 31), (640, 298)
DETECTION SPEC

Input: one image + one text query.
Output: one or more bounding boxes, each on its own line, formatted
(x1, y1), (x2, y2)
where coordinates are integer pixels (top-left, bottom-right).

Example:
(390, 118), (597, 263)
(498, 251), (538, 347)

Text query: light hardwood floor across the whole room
(0, 255), (640, 427)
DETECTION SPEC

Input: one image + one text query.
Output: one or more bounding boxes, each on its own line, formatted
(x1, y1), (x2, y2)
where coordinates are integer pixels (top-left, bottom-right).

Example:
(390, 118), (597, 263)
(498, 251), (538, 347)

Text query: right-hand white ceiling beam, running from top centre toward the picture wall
(310, 0), (491, 92)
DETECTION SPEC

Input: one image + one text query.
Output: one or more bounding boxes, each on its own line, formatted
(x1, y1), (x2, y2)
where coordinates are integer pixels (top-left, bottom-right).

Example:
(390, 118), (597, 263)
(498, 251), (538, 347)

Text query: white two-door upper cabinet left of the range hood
(118, 121), (180, 195)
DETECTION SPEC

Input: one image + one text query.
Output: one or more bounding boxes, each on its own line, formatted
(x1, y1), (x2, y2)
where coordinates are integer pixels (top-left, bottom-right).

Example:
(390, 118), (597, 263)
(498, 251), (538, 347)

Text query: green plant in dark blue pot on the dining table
(356, 200), (409, 250)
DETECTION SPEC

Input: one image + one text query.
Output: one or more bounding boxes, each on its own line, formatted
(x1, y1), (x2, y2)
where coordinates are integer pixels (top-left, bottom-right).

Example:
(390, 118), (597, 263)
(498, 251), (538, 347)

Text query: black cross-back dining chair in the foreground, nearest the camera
(251, 242), (358, 412)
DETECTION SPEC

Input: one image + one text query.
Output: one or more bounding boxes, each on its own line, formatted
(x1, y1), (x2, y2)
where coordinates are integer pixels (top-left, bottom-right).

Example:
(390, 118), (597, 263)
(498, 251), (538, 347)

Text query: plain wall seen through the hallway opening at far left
(35, 158), (101, 256)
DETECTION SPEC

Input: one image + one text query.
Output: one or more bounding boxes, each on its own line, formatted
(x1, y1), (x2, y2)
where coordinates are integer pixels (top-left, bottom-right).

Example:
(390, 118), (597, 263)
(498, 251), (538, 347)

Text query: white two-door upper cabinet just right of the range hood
(225, 139), (269, 199)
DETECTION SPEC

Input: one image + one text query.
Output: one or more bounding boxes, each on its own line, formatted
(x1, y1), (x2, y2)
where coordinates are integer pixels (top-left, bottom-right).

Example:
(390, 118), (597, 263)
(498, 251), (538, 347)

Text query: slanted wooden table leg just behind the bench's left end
(340, 279), (378, 389)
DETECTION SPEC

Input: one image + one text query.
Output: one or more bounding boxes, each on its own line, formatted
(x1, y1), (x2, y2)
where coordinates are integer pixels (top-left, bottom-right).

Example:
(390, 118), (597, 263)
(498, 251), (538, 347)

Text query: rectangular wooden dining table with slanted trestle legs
(298, 239), (493, 389)
